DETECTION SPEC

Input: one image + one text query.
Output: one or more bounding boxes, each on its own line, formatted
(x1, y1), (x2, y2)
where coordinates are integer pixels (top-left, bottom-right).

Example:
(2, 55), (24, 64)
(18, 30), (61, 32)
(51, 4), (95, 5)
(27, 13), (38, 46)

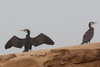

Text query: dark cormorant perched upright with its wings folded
(81, 22), (97, 44)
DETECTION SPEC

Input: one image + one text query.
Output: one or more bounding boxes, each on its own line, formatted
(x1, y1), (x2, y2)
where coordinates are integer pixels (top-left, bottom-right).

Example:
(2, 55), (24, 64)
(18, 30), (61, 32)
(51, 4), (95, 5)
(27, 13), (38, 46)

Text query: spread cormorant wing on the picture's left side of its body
(5, 36), (25, 49)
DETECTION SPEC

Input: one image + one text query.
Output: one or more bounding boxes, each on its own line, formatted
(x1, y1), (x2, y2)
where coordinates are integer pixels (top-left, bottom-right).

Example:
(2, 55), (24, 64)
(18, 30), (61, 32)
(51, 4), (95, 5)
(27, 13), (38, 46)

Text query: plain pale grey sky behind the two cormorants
(0, 0), (100, 54)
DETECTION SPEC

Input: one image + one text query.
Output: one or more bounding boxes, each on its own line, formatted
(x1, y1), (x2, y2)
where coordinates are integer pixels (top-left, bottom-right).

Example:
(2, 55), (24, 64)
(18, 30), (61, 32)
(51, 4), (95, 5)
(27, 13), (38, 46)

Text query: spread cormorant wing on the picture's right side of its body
(30, 33), (54, 46)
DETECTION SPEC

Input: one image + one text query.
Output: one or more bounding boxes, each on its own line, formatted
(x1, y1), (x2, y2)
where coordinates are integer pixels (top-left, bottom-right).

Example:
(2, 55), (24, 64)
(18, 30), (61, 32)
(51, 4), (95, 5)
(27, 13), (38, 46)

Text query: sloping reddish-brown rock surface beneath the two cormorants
(0, 43), (100, 67)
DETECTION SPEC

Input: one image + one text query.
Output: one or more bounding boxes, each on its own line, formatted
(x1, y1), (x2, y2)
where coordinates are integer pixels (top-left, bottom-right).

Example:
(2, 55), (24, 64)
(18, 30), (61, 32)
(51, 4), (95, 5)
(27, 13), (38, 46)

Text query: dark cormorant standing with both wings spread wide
(5, 29), (54, 52)
